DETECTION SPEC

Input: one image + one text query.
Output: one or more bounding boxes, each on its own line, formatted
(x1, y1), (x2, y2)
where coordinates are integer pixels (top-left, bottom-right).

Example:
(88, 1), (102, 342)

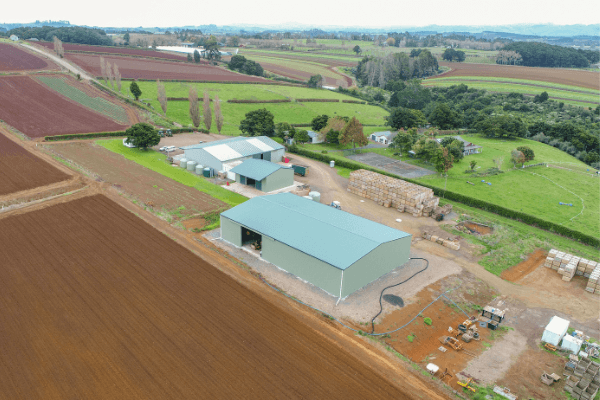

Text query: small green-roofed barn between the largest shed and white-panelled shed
(229, 159), (294, 193)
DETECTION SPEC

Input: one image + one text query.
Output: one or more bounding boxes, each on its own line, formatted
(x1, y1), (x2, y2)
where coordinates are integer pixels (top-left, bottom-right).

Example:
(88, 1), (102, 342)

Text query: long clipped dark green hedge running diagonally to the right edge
(288, 146), (600, 248)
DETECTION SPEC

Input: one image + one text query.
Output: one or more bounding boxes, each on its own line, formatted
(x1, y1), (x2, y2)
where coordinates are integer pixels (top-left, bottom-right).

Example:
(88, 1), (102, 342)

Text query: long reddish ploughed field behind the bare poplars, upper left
(65, 53), (269, 82)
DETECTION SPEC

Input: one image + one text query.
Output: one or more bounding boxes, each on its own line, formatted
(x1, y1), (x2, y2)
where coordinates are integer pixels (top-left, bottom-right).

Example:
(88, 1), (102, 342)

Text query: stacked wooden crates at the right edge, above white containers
(544, 249), (600, 295)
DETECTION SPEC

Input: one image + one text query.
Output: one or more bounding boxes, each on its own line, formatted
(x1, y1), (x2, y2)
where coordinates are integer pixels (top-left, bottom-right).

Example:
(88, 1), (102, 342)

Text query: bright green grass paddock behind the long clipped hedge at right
(419, 136), (600, 236)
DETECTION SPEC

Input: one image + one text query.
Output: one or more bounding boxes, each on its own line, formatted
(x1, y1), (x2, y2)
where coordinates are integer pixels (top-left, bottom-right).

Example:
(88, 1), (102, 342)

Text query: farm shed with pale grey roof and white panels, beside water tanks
(181, 136), (285, 179)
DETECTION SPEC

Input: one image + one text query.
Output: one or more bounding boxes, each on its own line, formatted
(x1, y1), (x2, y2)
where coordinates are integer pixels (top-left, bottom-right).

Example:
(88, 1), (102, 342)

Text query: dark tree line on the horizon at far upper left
(8, 26), (113, 46)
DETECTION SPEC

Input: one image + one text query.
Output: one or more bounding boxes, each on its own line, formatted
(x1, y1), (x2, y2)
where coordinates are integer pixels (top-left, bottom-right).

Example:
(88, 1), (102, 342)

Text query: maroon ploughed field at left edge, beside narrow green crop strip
(0, 76), (128, 138)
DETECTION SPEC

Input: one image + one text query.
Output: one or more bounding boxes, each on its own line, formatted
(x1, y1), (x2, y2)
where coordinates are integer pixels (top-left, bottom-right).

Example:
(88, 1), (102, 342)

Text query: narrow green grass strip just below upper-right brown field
(423, 78), (600, 107)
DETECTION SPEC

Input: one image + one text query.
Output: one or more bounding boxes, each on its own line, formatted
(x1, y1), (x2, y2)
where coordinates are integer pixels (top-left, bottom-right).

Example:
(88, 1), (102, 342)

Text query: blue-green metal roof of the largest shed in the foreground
(221, 193), (410, 270)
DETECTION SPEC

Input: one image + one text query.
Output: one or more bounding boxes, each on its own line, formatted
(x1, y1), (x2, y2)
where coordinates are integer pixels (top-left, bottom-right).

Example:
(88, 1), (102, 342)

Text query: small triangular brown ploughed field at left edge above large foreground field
(0, 133), (69, 196)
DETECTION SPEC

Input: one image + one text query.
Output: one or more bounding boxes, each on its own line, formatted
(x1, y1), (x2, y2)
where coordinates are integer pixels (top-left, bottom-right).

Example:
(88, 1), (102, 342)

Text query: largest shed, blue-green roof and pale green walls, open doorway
(221, 193), (411, 298)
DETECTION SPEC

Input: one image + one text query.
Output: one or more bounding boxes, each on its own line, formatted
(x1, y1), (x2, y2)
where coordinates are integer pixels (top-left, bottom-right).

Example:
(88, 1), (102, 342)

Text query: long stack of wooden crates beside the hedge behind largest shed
(348, 169), (440, 217)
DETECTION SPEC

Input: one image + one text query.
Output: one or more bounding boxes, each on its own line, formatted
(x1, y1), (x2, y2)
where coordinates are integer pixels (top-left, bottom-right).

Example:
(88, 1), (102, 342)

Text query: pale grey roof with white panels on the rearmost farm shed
(181, 136), (284, 161)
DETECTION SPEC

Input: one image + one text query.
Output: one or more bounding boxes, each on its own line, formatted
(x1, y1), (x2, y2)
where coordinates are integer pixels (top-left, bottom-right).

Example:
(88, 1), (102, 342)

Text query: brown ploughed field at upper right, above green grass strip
(439, 62), (600, 90)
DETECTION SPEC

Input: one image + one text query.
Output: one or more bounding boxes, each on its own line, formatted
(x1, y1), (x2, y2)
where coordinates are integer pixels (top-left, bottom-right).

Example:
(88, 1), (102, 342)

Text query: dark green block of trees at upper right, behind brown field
(496, 42), (600, 68)
